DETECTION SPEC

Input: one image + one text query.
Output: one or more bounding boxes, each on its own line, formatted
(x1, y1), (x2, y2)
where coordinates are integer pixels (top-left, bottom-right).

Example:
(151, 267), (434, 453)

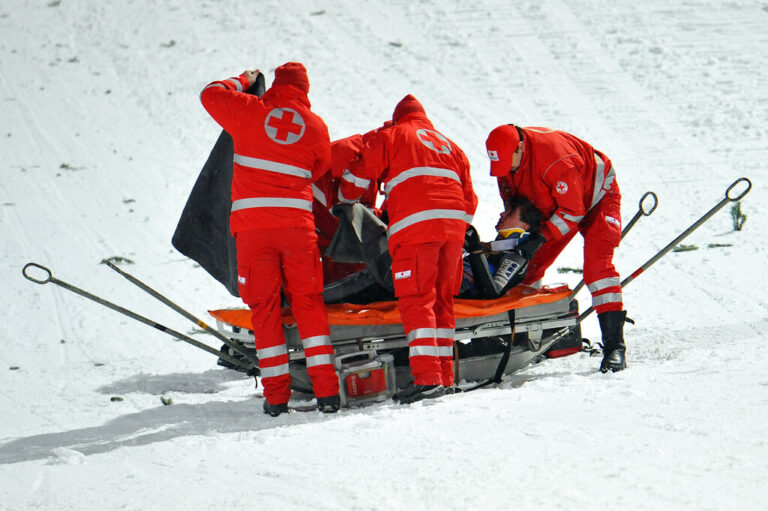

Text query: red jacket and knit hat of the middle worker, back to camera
(339, 96), (477, 245)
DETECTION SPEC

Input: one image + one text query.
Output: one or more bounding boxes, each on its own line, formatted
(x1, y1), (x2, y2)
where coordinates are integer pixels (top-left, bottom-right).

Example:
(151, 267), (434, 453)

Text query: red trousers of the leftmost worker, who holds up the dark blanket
(235, 228), (339, 404)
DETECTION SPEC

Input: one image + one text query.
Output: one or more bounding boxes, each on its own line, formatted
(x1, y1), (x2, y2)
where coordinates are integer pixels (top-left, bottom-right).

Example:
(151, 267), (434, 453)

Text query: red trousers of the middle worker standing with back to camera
(390, 237), (464, 386)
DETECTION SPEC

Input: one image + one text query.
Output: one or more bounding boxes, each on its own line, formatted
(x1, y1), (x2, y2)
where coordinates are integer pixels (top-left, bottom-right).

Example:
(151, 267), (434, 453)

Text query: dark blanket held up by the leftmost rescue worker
(171, 74), (265, 296)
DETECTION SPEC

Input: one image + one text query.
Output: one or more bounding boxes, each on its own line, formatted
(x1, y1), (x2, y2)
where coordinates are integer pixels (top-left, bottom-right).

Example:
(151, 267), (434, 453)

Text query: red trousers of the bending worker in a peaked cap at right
(523, 181), (624, 314)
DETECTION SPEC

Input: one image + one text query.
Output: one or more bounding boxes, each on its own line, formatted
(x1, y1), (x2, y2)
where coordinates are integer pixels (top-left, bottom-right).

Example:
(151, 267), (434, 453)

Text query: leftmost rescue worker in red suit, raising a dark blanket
(200, 62), (339, 417)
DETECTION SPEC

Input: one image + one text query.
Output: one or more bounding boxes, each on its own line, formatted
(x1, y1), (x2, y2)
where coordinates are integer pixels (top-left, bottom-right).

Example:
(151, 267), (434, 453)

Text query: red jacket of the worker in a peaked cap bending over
(497, 127), (615, 241)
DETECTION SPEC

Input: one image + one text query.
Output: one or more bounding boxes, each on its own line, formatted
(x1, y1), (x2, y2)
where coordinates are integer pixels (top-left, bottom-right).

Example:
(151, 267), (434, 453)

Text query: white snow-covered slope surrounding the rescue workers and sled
(0, 0), (768, 510)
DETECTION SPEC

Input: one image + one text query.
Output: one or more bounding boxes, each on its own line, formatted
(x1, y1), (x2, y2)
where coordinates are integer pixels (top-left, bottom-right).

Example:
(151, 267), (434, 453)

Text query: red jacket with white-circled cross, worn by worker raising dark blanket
(200, 75), (331, 233)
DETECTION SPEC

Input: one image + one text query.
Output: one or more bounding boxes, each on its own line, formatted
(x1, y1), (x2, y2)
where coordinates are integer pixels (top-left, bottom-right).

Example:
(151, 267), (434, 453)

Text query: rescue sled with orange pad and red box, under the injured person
(209, 285), (582, 405)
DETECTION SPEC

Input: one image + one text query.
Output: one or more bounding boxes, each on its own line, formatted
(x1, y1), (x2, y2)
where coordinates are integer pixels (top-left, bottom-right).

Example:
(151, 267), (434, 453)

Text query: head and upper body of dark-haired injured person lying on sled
(459, 195), (541, 299)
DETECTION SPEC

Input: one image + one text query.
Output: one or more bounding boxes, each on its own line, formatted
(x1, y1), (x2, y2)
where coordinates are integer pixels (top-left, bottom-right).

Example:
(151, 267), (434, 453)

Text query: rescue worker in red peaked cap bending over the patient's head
(485, 124), (627, 372)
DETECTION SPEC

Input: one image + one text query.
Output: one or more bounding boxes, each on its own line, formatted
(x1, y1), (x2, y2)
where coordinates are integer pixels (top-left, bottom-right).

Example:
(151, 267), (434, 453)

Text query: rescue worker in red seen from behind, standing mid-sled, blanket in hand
(339, 95), (477, 403)
